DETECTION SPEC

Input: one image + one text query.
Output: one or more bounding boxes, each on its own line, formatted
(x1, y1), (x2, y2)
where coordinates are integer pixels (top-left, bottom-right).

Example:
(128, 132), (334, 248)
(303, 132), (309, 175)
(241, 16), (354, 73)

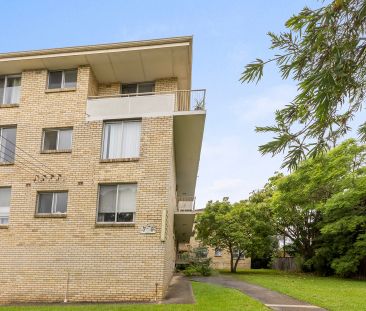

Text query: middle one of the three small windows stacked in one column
(42, 128), (72, 151)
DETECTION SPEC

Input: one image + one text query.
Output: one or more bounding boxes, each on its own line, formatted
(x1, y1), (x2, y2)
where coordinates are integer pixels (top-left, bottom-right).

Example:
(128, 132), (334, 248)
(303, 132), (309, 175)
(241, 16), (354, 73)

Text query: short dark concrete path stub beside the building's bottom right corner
(162, 274), (196, 304)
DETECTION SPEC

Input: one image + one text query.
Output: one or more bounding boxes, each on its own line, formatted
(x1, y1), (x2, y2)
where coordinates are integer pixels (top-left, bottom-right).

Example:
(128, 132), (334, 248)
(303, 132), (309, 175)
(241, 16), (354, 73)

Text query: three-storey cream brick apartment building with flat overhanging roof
(0, 37), (205, 304)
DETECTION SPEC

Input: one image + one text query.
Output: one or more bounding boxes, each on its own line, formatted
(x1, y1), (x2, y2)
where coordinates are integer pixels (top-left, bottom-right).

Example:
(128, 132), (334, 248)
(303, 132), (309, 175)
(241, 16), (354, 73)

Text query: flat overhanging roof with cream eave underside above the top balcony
(0, 36), (193, 89)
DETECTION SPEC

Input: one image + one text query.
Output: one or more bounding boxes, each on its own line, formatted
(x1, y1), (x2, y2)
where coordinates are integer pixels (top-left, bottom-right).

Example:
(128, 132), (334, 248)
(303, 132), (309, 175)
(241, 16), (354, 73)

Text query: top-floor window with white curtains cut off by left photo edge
(0, 75), (21, 105)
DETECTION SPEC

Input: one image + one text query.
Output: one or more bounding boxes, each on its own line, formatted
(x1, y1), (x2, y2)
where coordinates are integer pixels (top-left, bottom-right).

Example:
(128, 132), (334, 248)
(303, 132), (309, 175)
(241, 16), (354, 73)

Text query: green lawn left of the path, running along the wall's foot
(0, 282), (269, 311)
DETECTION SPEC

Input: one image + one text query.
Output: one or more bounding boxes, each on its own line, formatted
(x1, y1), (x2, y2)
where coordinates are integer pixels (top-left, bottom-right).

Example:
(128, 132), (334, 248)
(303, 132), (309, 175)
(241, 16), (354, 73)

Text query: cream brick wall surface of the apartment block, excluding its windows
(0, 67), (175, 304)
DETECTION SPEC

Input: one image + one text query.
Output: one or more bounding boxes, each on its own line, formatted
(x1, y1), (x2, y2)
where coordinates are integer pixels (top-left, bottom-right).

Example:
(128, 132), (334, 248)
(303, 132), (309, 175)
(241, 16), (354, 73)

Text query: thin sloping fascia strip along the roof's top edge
(0, 36), (193, 60)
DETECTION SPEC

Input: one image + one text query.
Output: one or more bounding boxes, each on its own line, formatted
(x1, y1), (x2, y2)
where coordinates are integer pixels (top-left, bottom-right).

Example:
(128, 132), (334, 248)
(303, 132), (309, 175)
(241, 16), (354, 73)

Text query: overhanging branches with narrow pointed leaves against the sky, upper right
(241, 0), (366, 169)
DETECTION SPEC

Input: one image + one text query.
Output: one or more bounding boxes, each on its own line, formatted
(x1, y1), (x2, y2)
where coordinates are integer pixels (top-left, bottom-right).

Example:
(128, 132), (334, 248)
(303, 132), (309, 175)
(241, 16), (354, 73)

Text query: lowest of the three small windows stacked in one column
(37, 191), (68, 214)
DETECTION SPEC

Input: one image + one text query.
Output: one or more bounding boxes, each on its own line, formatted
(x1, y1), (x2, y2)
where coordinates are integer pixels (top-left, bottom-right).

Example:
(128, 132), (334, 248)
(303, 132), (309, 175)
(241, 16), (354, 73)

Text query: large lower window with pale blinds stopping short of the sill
(97, 184), (137, 223)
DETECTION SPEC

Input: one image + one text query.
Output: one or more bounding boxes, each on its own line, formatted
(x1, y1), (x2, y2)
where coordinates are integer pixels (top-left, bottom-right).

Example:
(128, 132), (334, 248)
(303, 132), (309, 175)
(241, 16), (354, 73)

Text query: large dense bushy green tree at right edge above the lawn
(272, 140), (366, 276)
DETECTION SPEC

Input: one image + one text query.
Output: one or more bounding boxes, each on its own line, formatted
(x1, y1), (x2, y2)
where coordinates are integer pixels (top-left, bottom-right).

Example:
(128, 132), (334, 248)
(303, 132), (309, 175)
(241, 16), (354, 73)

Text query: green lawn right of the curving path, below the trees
(221, 270), (366, 311)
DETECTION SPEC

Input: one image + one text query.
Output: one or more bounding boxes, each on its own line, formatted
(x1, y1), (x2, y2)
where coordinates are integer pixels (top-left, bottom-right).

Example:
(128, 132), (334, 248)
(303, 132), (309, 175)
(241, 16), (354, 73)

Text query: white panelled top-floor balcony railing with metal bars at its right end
(86, 89), (206, 121)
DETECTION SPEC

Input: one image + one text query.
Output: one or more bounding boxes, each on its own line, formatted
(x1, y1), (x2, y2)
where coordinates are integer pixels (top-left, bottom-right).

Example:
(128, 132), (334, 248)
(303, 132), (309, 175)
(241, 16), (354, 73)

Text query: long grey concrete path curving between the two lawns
(191, 276), (325, 311)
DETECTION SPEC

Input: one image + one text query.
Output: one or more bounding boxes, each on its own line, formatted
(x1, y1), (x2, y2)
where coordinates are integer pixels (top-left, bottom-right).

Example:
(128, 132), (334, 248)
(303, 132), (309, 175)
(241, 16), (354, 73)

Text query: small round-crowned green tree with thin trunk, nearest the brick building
(195, 198), (273, 272)
